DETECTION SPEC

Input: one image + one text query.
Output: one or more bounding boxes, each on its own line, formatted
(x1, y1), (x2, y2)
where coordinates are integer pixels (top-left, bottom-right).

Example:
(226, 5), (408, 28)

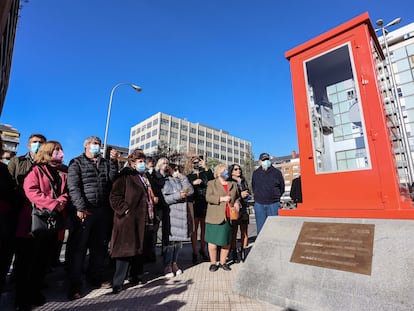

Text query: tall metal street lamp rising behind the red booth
(375, 17), (414, 186)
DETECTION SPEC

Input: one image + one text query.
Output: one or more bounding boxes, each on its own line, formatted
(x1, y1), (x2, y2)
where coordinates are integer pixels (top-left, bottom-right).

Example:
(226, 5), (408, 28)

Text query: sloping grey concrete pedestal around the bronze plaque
(233, 216), (414, 311)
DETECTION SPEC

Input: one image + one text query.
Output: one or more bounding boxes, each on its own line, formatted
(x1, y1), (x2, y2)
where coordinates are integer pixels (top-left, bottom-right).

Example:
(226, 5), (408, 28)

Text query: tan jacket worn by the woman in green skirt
(206, 178), (240, 225)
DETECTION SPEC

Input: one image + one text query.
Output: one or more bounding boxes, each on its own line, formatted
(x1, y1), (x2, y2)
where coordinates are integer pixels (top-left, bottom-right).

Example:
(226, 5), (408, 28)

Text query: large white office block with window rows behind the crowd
(129, 112), (251, 165)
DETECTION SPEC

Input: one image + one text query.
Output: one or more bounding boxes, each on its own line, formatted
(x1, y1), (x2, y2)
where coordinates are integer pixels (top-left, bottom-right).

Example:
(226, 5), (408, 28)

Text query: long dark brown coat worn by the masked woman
(109, 169), (148, 258)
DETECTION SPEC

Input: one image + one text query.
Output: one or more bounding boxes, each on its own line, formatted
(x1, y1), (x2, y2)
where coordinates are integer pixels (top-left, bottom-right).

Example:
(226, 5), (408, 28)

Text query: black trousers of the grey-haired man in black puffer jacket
(66, 208), (111, 291)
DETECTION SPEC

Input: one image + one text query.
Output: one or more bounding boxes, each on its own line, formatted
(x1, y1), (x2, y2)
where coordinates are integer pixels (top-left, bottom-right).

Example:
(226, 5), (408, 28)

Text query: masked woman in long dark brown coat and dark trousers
(109, 152), (150, 294)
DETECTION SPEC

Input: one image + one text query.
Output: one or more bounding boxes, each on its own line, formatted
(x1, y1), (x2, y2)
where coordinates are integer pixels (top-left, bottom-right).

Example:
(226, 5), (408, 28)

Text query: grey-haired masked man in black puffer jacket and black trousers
(67, 136), (118, 299)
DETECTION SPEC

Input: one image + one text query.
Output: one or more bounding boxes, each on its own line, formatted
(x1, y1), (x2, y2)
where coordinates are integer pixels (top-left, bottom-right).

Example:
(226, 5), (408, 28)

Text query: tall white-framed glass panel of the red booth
(304, 43), (371, 174)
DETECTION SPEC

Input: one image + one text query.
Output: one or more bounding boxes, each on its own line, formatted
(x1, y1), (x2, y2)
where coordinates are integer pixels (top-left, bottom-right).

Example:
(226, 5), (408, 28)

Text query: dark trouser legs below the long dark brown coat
(112, 255), (144, 287)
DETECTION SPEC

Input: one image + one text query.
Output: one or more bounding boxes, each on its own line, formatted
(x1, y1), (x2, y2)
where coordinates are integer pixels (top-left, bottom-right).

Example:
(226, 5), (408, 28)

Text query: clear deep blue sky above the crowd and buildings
(0, 0), (414, 163)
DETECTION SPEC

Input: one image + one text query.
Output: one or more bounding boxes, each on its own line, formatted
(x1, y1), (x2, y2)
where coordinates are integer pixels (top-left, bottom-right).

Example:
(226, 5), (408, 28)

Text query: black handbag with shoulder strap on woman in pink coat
(30, 166), (64, 237)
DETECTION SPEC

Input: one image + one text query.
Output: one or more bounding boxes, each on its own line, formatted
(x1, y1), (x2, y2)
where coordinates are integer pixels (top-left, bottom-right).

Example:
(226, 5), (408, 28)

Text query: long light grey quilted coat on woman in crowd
(162, 175), (194, 245)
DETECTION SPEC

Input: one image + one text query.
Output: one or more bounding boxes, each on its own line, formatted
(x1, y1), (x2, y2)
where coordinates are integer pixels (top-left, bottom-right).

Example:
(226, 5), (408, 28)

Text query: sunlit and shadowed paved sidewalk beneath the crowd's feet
(0, 219), (282, 311)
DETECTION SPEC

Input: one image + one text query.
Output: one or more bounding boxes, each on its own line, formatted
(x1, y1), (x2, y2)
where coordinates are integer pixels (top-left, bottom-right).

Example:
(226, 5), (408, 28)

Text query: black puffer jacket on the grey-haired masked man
(68, 153), (118, 211)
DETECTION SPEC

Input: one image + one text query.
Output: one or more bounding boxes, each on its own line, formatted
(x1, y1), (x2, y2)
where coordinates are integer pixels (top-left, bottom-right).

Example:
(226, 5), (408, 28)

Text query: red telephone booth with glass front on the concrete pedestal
(280, 13), (414, 219)
